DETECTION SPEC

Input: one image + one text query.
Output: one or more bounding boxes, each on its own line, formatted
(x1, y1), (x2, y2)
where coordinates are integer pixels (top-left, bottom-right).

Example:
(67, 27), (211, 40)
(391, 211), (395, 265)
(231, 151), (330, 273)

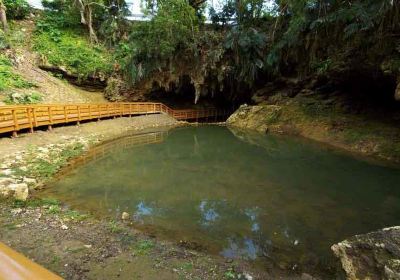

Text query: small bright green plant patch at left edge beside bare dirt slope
(0, 54), (35, 91)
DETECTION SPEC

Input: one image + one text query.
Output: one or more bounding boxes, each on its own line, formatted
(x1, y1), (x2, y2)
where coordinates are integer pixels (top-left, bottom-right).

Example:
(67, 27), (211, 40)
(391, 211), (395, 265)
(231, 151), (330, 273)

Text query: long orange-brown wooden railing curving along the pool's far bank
(0, 102), (228, 136)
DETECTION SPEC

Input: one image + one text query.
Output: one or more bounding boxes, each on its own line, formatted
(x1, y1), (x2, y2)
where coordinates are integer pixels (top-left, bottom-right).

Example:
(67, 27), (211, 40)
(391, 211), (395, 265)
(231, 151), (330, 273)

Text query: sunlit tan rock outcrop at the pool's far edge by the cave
(226, 105), (282, 132)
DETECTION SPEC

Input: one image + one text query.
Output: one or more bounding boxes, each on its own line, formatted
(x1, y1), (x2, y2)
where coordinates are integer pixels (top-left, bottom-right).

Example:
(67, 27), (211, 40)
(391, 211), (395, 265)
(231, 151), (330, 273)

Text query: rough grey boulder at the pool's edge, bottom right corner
(331, 227), (400, 280)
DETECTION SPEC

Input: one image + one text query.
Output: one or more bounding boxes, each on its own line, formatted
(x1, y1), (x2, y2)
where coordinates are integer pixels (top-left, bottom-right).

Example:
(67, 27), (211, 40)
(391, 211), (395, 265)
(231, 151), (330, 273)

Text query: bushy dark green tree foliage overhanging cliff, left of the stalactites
(128, 0), (199, 81)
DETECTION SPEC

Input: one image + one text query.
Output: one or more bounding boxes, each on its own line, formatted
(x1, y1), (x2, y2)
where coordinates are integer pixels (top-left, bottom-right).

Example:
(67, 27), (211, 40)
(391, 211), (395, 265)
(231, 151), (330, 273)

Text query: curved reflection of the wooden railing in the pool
(58, 132), (168, 175)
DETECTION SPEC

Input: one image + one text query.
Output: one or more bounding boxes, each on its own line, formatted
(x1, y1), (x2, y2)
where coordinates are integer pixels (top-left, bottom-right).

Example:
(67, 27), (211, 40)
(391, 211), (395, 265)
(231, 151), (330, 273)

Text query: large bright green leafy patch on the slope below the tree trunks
(34, 14), (113, 79)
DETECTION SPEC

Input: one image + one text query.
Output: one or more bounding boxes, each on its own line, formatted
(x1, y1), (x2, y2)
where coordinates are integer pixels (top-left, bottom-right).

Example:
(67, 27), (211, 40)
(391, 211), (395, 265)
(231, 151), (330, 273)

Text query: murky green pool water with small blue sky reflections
(43, 126), (400, 276)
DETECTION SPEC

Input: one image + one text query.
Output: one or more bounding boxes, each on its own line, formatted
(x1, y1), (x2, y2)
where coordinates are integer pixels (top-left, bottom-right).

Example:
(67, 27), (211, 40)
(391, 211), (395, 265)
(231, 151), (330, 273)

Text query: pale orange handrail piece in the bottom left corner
(0, 242), (62, 280)
